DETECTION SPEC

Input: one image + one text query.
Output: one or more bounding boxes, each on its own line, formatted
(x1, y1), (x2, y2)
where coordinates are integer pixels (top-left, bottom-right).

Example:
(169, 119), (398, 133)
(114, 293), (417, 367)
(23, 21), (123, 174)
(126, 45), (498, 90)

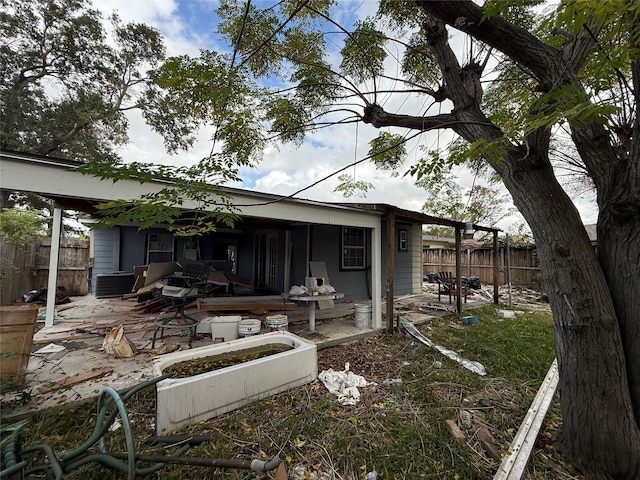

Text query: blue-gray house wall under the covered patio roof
(92, 218), (421, 302)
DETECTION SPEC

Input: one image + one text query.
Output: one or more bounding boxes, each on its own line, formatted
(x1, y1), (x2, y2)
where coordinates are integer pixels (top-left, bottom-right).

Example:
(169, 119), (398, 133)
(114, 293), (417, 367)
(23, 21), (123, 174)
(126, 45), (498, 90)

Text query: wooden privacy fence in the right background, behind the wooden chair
(423, 247), (542, 290)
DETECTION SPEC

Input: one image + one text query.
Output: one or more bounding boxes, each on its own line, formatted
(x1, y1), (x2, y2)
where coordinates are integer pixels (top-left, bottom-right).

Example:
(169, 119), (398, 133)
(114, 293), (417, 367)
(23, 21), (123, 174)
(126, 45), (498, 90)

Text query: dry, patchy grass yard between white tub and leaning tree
(0, 307), (580, 480)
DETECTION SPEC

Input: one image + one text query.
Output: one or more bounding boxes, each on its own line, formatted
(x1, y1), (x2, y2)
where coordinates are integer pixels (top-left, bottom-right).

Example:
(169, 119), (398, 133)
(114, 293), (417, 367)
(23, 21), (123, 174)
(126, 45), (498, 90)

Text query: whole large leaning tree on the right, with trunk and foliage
(145, 0), (640, 479)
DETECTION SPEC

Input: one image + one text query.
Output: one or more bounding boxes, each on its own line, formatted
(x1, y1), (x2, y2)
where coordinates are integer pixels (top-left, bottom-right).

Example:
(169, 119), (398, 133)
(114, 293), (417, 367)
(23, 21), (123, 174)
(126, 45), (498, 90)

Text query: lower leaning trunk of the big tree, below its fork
(496, 149), (640, 479)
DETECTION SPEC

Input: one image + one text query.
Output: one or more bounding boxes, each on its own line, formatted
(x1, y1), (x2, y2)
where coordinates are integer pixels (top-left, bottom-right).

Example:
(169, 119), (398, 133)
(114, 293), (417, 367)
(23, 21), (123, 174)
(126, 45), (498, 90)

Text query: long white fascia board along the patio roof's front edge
(0, 156), (381, 228)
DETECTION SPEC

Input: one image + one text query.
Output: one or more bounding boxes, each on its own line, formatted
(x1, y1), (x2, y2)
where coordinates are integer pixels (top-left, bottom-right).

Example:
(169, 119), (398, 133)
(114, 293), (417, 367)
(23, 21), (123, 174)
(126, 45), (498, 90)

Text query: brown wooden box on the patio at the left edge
(0, 305), (38, 386)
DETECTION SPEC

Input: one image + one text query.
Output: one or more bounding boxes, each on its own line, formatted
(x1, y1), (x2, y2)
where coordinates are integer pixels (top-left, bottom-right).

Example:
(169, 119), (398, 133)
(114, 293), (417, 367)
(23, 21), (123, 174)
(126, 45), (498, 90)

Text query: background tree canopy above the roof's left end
(0, 0), (165, 161)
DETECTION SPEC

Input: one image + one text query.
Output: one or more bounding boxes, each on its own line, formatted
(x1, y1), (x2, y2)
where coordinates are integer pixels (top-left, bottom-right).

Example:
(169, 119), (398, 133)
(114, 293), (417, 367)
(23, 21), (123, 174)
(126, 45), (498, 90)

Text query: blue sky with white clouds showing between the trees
(94, 0), (594, 228)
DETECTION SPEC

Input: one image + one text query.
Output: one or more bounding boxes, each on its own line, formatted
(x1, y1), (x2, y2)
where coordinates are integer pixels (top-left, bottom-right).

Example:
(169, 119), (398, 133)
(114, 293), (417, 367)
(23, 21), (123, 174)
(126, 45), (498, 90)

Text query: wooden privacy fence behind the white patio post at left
(0, 238), (90, 305)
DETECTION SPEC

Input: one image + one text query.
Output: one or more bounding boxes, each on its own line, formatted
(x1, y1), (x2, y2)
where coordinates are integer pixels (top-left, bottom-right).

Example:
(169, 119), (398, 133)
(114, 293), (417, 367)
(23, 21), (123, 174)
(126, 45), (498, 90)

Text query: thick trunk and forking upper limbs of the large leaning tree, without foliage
(404, 0), (640, 480)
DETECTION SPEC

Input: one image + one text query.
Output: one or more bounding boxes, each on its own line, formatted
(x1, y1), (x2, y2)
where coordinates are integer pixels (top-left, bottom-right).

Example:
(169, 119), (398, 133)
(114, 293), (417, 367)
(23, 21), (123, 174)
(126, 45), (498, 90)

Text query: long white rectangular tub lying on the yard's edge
(153, 331), (318, 435)
